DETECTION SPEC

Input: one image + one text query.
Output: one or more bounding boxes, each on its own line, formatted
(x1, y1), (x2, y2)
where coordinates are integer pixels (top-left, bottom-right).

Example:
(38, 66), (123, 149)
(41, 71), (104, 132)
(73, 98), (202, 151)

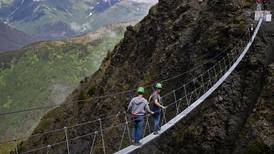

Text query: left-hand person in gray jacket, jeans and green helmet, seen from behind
(128, 87), (154, 146)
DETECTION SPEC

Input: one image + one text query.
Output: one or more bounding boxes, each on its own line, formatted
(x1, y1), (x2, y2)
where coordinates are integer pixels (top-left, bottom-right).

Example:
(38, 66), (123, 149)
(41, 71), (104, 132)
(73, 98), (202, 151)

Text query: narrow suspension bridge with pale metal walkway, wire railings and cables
(0, 18), (263, 154)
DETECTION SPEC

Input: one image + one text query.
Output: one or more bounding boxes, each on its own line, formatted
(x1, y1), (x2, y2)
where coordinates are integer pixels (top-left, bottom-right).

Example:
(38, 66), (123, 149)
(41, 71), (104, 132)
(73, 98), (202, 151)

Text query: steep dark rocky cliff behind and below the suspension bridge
(16, 0), (273, 153)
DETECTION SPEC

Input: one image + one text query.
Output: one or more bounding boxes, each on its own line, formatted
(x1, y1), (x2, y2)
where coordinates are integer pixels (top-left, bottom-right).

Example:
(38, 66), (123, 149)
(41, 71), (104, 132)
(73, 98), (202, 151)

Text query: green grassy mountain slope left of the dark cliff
(0, 25), (124, 148)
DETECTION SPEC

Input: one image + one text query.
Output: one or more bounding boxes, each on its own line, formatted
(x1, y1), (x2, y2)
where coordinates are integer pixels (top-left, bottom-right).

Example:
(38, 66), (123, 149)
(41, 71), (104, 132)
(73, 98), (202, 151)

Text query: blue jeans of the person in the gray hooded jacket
(132, 115), (144, 143)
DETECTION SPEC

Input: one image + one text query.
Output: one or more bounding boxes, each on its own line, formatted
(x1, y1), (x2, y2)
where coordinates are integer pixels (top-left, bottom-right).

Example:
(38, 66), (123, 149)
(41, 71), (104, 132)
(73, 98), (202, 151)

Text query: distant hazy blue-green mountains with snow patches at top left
(0, 0), (155, 39)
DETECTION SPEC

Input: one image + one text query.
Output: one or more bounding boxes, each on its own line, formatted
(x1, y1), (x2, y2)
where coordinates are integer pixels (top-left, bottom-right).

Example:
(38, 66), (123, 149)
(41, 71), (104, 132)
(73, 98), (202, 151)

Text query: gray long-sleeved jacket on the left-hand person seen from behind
(128, 96), (151, 115)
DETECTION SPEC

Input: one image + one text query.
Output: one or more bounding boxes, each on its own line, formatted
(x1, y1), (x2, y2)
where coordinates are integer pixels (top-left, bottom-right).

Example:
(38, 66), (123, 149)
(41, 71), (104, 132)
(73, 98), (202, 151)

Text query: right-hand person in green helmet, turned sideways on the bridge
(149, 83), (166, 135)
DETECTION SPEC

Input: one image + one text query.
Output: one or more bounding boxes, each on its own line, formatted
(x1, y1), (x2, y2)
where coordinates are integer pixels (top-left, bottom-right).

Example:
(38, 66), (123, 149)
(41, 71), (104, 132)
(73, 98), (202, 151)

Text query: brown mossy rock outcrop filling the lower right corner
(234, 64), (274, 154)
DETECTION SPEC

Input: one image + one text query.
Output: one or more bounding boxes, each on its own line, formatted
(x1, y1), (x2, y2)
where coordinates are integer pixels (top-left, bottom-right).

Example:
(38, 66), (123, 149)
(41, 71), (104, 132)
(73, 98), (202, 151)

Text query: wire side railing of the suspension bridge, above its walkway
(5, 21), (258, 154)
